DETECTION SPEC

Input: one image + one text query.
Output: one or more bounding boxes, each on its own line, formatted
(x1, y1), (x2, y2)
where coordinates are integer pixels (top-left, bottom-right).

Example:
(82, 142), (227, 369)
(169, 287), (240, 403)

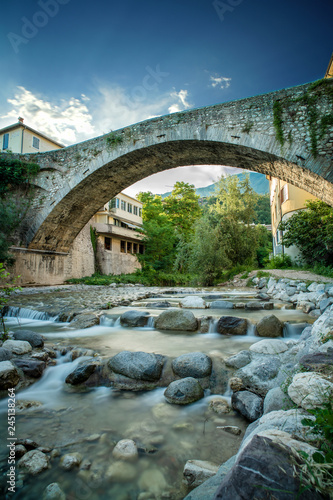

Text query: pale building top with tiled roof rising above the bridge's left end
(0, 117), (64, 153)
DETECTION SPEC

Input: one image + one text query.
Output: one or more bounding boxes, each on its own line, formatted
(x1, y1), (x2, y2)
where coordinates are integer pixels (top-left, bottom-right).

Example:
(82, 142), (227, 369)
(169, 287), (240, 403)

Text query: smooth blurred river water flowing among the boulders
(0, 292), (309, 500)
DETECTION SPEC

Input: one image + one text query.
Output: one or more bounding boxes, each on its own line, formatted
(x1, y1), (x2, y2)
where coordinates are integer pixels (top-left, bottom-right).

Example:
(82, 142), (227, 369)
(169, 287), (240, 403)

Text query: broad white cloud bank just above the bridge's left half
(0, 83), (195, 145)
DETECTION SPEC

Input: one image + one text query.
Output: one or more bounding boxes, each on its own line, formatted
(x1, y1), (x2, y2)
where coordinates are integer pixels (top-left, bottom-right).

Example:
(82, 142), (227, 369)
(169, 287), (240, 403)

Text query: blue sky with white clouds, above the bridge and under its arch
(0, 0), (333, 196)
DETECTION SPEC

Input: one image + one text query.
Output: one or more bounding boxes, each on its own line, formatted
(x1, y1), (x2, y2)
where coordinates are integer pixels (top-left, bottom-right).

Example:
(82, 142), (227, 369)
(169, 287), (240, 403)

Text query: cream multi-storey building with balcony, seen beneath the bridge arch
(90, 193), (144, 274)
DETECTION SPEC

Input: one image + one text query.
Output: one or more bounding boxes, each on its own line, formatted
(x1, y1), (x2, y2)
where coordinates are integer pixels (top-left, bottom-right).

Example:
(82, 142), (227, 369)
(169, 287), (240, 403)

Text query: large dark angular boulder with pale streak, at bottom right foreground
(214, 434), (322, 500)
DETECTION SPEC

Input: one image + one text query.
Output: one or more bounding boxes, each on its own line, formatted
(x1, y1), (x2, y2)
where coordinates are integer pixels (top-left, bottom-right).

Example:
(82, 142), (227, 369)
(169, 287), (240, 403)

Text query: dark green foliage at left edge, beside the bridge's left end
(0, 153), (40, 265)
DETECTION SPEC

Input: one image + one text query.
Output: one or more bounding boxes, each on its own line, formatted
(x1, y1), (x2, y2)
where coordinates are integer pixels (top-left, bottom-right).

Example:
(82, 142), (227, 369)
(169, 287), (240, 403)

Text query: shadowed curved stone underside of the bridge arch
(26, 140), (333, 252)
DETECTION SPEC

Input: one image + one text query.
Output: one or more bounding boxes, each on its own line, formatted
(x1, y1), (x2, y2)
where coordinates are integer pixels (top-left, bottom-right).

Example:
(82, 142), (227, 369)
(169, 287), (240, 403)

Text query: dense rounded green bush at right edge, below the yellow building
(279, 200), (333, 266)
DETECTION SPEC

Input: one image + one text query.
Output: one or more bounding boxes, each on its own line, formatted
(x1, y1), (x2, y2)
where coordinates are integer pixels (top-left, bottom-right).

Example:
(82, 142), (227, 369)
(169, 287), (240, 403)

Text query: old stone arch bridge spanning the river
(3, 79), (333, 284)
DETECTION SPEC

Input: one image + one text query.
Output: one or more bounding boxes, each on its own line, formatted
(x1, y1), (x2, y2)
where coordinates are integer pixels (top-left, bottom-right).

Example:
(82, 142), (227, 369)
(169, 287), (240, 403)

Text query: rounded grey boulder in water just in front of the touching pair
(164, 377), (204, 405)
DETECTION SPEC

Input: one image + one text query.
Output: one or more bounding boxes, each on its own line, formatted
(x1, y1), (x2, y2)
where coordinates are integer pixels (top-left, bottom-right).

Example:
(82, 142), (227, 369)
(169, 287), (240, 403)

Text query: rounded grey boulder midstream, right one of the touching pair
(172, 352), (212, 378)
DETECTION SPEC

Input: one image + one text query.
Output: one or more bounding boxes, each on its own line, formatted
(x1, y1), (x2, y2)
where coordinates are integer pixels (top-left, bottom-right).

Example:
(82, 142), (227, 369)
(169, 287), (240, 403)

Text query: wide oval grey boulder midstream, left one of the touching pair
(108, 351), (164, 381)
